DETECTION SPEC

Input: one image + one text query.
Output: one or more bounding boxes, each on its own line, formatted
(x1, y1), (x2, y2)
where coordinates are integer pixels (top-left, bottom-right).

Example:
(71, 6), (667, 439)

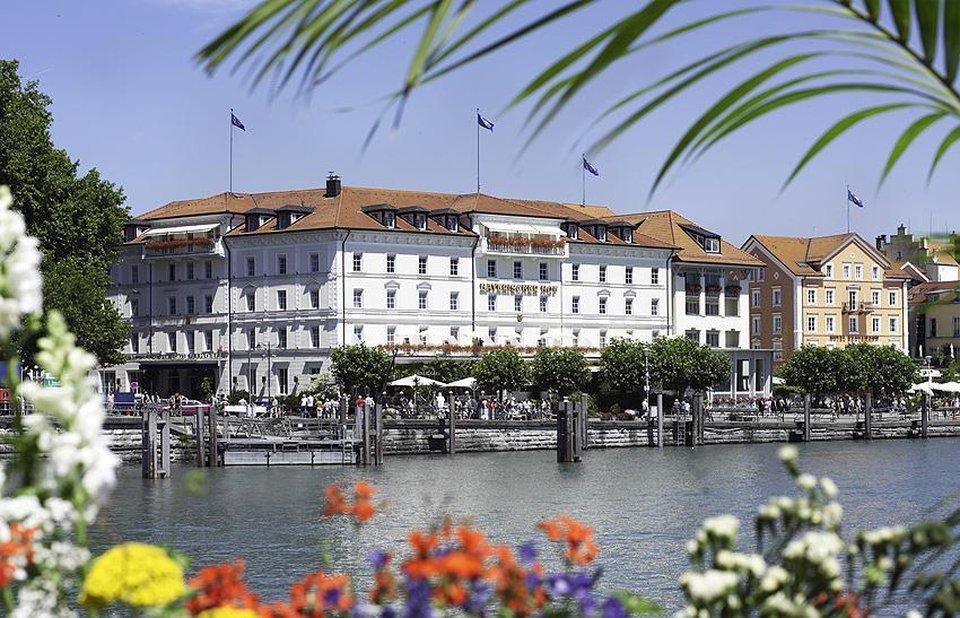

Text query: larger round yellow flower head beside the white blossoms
(79, 543), (187, 607)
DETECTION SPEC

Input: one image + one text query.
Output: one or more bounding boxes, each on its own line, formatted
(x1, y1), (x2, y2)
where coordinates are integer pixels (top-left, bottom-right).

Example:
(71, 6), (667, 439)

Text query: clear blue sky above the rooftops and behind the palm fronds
(7, 0), (960, 242)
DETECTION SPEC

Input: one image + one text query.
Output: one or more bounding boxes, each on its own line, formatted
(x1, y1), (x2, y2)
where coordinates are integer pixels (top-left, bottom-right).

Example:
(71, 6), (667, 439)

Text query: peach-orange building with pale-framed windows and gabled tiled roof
(743, 233), (909, 362)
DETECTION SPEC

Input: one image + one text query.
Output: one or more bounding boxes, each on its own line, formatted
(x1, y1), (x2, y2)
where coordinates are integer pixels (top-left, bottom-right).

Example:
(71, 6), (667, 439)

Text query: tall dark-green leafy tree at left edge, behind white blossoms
(0, 60), (129, 364)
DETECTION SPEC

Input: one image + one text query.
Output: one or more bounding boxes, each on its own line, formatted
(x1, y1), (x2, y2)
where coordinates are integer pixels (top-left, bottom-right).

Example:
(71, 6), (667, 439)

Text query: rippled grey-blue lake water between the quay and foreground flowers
(91, 439), (960, 607)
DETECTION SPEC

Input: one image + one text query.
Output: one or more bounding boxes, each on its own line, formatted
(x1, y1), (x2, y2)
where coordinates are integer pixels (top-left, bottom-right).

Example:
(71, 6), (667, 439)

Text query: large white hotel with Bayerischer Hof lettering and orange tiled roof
(103, 177), (770, 395)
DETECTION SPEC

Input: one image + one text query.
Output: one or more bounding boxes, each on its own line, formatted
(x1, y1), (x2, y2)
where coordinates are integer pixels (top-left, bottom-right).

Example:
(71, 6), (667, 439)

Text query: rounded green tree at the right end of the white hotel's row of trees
(650, 337), (730, 397)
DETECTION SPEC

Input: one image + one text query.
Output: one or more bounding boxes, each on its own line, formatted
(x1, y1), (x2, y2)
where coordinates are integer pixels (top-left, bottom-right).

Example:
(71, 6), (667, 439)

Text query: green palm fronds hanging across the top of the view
(197, 0), (960, 190)
